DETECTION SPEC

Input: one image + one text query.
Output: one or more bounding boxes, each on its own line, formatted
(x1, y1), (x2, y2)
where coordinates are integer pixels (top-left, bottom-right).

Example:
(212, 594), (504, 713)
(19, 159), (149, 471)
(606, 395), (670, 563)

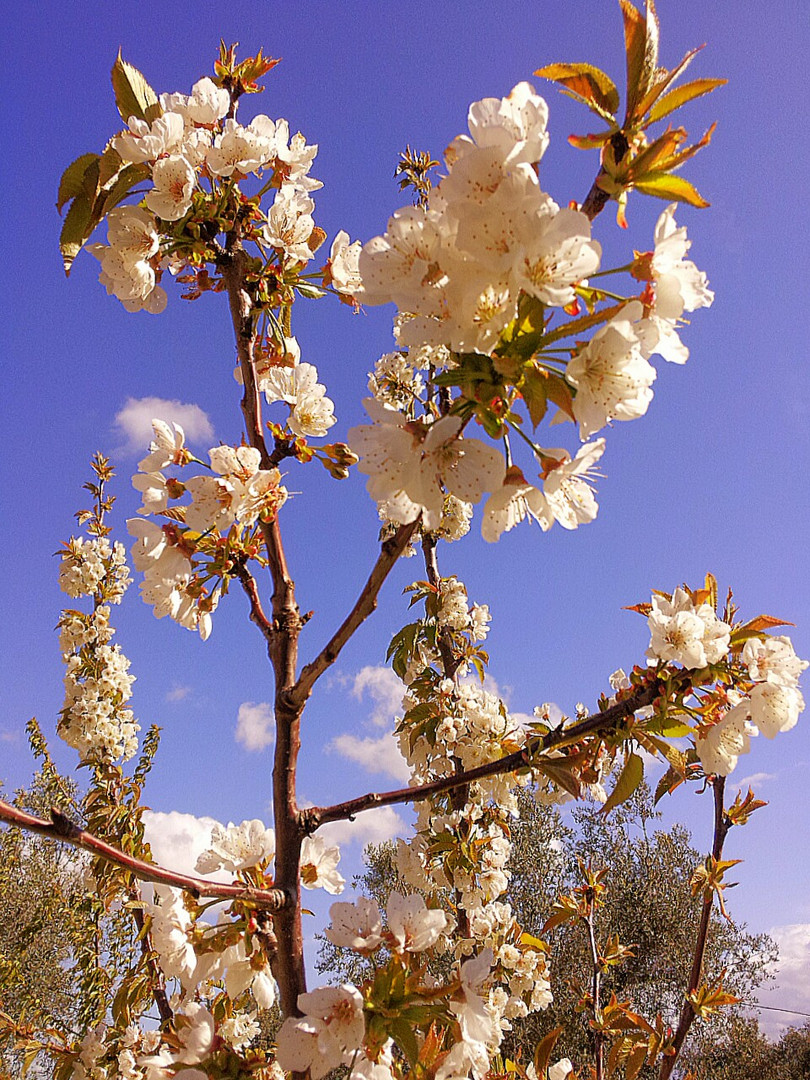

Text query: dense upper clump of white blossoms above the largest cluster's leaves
(360, 82), (600, 352)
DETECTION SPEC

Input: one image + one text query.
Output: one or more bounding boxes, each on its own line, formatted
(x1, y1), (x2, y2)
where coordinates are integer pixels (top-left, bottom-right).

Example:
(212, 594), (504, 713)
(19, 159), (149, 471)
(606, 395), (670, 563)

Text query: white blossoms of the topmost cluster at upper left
(89, 78), (361, 314)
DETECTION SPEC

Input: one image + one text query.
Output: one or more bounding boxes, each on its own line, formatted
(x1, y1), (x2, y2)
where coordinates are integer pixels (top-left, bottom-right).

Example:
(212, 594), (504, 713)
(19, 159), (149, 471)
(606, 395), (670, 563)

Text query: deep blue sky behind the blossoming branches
(0, 0), (810, 1028)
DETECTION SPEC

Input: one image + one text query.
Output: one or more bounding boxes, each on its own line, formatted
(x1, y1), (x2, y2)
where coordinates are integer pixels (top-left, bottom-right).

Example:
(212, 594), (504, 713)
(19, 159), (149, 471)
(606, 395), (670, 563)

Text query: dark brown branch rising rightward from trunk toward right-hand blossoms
(301, 673), (669, 833)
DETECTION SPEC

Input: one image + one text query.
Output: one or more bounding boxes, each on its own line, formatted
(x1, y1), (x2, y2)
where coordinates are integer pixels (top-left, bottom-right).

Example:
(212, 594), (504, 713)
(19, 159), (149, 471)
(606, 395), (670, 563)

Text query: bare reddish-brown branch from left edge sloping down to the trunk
(0, 799), (289, 912)
